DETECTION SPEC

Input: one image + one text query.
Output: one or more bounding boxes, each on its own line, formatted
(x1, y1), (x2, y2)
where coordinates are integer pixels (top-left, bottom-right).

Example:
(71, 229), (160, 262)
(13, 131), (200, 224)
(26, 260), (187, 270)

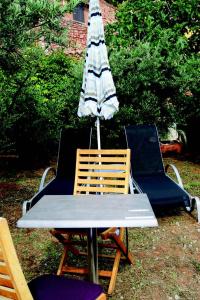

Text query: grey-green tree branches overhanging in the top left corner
(0, 0), (79, 73)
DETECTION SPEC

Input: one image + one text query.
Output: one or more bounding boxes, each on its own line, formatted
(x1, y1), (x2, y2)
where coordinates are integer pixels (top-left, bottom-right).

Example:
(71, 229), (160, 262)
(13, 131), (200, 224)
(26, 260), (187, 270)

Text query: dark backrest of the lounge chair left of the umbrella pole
(56, 128), (91, 180)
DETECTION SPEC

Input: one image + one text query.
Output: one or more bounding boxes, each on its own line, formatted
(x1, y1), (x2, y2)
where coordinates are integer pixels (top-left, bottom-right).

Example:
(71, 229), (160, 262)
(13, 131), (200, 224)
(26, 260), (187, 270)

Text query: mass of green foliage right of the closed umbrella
(106, 0), (200, 138)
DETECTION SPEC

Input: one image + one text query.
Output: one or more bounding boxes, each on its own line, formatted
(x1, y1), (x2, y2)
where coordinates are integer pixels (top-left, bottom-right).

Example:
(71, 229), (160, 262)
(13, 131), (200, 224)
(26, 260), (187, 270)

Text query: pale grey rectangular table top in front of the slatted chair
(17, 194), (158, 228)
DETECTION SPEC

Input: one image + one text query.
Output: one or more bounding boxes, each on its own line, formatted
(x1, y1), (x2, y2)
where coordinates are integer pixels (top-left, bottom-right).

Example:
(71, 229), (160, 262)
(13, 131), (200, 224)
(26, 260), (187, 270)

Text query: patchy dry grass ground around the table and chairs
(0, 158), (200, 300)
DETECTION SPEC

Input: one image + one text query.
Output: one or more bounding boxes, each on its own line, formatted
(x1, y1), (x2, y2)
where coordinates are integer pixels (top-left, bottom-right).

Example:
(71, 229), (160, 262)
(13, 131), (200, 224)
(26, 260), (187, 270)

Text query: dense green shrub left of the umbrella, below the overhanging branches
(0, 49), (85, 164)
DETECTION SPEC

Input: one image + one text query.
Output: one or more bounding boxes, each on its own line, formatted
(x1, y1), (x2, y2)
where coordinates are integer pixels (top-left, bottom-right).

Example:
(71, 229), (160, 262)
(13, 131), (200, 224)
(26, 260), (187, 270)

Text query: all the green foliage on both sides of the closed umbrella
(0, 0), (200, 162)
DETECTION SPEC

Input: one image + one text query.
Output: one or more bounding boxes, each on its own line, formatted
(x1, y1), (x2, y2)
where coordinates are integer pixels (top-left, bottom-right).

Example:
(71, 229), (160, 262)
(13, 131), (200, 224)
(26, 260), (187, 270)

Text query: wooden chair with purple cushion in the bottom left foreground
(0, 218), (106, 300)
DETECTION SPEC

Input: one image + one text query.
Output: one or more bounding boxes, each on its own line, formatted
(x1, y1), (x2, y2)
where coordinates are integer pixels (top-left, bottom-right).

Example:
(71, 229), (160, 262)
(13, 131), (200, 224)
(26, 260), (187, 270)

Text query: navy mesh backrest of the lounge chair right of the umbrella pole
(125, 125), (164, 176)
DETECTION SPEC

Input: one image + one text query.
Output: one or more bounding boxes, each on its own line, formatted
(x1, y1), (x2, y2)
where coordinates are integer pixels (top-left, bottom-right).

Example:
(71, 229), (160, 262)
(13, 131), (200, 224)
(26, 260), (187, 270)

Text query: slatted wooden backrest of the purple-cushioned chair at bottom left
(0, 218), (33, 300)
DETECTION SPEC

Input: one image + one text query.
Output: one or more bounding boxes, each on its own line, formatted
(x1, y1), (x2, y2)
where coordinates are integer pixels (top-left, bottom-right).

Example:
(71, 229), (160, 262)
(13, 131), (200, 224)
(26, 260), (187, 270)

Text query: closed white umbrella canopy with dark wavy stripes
(78, 0), (119, 119)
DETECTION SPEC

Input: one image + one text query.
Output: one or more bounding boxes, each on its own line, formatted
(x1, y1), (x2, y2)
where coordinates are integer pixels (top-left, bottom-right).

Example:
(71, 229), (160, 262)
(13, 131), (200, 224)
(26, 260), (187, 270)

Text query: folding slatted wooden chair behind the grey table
(54, 149), (134, 294)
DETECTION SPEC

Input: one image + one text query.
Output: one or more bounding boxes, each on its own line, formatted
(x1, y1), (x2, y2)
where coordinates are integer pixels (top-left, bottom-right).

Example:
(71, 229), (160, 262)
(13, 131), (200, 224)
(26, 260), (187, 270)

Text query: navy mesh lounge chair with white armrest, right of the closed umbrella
(125, 125), (199, 219)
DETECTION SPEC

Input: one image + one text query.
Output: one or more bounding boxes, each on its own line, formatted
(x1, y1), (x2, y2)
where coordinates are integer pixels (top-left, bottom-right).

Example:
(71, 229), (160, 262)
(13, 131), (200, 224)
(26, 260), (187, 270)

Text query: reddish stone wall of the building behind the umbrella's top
(63, 0), (115, 55)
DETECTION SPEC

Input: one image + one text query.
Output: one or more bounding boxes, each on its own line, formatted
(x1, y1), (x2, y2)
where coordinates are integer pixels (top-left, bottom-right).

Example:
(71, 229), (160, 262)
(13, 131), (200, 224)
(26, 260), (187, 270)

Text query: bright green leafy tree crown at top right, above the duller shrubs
(106, 0), (199, 53)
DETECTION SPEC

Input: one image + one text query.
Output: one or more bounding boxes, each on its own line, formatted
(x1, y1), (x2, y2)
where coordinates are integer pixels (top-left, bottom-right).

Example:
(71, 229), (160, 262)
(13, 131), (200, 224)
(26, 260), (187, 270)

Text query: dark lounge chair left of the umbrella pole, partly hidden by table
(23, 128), (91, 213)
